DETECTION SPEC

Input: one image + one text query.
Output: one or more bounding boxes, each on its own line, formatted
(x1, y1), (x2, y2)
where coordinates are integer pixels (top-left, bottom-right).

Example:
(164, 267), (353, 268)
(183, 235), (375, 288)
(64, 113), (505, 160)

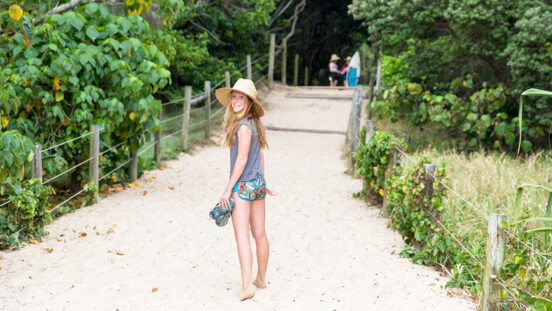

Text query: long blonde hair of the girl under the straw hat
(221, 96), (268, 149)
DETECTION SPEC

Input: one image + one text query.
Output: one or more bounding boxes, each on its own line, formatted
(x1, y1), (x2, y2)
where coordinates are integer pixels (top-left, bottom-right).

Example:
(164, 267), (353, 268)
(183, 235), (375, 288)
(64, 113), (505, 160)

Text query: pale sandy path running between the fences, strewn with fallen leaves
(0, 84), (475, 310)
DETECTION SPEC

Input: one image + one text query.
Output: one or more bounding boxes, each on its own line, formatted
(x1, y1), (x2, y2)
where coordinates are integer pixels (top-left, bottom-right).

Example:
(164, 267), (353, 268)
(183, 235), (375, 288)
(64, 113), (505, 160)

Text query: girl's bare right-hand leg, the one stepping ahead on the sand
(250, 200), (269, 288)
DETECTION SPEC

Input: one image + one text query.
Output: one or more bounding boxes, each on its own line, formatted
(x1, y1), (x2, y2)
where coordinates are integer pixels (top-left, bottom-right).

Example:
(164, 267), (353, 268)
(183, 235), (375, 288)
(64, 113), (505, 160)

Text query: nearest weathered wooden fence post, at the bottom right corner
(479, 214), (506, 311)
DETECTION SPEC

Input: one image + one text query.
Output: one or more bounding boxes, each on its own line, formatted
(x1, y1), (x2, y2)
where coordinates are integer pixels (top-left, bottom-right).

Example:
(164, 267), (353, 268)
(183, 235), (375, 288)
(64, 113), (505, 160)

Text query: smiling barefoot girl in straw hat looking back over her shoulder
(215, 79), (277, 300)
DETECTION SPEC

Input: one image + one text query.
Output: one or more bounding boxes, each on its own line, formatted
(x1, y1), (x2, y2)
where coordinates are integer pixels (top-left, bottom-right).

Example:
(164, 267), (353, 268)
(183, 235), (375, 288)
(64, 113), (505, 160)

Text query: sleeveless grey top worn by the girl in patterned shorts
(230, 118), (264, 181)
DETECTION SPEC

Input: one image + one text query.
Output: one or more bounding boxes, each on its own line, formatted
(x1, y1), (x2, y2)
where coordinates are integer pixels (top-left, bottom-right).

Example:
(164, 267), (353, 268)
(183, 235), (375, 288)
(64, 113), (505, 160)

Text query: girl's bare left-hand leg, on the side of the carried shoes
(232, 192), (255, 300)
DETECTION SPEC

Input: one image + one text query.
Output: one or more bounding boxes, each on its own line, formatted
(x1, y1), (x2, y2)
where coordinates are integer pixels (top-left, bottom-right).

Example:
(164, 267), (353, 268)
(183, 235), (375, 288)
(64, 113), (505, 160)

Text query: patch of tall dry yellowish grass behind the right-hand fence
(377, 117), (552, 241)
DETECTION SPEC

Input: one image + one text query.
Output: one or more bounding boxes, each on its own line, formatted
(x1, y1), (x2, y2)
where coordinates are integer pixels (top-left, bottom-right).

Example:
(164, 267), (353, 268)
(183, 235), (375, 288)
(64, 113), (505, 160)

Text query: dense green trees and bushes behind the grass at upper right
(349, 0), (552, 151)
